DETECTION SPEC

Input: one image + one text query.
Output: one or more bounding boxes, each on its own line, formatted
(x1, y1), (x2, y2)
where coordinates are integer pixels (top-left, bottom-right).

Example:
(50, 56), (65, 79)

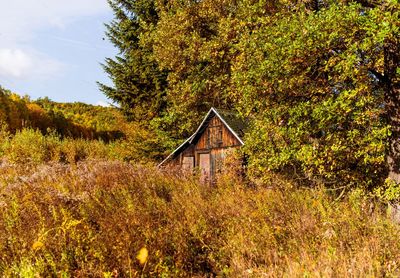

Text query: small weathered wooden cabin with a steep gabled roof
(159, 108), (245, 182)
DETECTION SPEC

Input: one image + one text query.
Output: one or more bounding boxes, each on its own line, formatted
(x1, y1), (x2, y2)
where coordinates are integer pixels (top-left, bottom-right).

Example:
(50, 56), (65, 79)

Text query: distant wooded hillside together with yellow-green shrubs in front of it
(0, 87), (167, 164)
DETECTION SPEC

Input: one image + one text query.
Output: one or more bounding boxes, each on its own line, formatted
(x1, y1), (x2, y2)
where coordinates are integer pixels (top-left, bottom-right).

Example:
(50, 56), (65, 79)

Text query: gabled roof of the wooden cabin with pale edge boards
(158, 107), (246, 166)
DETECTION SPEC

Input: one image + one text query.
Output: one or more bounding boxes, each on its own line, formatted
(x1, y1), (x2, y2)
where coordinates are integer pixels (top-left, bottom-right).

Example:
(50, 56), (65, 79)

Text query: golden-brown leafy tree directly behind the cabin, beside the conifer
(154, 0), (283, 138)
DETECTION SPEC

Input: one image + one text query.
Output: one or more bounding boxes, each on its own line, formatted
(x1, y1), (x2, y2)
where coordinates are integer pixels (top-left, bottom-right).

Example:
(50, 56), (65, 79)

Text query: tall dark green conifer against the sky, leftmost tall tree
(99, 0), (167, 123)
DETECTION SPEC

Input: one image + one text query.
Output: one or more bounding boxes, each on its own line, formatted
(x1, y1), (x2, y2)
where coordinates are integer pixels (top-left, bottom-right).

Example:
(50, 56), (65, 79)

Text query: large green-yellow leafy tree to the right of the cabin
(233, 1), (400, 187)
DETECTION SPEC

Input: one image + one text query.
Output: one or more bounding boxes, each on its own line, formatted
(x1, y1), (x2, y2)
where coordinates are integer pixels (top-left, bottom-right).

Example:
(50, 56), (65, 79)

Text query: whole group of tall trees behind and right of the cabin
(100, 0), (400, 188)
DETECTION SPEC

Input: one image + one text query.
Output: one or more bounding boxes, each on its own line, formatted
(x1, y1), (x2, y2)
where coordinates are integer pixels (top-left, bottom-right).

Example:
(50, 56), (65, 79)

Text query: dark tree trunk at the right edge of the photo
(384, 38), (400, 183)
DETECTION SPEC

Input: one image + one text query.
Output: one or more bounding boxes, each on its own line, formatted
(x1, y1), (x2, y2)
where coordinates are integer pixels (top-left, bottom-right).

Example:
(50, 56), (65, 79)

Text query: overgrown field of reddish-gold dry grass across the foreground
(0, 160), (400, 277)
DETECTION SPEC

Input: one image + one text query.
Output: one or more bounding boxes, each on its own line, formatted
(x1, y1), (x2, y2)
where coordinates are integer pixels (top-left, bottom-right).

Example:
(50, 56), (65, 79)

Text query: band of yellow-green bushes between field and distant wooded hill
(0, 125), (162, 166)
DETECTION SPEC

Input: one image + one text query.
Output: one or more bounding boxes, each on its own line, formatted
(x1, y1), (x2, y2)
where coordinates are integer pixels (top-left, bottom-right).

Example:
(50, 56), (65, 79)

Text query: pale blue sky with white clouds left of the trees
(0, 0), (117, 105)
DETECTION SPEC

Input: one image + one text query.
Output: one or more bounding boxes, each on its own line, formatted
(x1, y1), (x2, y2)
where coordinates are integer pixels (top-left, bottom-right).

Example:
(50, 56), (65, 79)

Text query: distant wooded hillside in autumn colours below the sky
(0, 87), (126, 141)
